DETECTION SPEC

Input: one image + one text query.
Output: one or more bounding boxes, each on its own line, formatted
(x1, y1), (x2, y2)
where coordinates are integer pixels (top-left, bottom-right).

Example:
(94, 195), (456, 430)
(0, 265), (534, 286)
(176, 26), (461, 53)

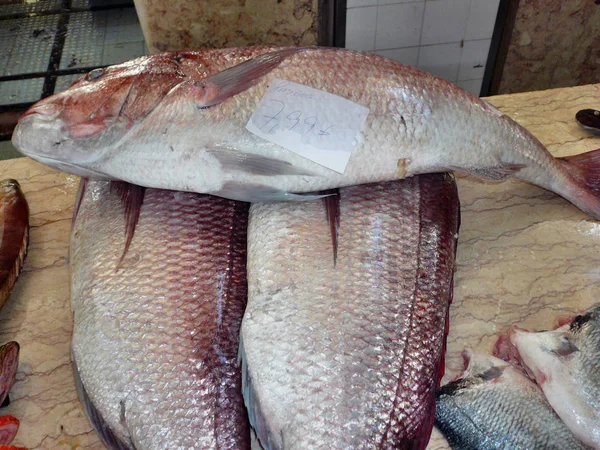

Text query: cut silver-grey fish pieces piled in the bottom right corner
(436, 305), (600, 450)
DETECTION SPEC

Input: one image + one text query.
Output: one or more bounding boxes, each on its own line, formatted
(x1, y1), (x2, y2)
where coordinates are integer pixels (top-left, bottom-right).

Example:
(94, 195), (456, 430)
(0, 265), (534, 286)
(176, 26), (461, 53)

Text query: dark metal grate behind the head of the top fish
(0, 0), (146, 113)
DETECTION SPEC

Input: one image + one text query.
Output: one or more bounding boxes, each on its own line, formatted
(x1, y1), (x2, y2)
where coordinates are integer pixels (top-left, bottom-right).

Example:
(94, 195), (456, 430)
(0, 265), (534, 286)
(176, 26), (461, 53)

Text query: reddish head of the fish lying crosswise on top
(12, 55), (185, 178)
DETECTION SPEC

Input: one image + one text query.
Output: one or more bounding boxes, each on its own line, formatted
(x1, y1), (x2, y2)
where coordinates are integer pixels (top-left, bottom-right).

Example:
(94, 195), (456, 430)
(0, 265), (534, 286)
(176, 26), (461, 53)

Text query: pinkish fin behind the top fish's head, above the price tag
(194, 47), (306, 108)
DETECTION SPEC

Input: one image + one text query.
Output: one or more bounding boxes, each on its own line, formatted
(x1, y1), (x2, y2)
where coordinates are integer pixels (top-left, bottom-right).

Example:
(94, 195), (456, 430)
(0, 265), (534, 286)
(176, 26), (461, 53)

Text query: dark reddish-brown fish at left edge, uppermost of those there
(0, 179), (29, 307)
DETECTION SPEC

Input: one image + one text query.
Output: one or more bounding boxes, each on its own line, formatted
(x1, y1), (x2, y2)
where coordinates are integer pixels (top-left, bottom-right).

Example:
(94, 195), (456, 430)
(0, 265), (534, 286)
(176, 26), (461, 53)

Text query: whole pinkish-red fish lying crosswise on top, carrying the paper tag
(12, 47), (600, 218)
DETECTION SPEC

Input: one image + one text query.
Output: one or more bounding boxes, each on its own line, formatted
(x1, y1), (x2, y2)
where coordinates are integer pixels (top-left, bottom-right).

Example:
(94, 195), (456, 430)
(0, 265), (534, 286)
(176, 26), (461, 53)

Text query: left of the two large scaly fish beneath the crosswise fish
(70, 181), (250, 450)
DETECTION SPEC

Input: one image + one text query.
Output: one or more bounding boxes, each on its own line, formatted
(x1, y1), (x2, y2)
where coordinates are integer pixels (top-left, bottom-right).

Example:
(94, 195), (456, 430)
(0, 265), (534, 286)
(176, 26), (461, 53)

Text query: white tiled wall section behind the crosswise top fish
(346, 0), (500, 95)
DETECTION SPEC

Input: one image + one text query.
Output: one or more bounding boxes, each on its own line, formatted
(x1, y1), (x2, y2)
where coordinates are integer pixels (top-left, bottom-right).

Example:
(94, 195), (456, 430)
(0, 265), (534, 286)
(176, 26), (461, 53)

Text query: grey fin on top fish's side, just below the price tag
(206, 149), (316, 176)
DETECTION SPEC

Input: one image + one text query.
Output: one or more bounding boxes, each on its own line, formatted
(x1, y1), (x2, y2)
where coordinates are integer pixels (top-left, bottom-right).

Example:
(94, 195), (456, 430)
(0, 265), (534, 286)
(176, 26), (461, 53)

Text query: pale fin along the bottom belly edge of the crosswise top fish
(210, 181), (330, 203)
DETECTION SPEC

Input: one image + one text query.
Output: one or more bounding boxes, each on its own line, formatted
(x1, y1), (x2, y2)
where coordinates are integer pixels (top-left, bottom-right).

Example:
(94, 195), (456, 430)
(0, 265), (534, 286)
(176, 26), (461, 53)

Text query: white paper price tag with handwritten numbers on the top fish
(246, 79), (369, 173)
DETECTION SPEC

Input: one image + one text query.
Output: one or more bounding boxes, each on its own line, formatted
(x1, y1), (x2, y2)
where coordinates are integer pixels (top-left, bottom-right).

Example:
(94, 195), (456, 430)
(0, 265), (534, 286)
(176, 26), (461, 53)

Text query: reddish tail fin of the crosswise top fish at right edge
(556, 149), (600, 219)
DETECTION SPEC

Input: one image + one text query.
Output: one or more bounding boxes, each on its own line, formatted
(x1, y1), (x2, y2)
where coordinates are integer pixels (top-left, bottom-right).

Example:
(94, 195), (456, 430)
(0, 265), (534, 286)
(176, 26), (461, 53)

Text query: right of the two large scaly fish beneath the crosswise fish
(240, 174), (459, 449)
